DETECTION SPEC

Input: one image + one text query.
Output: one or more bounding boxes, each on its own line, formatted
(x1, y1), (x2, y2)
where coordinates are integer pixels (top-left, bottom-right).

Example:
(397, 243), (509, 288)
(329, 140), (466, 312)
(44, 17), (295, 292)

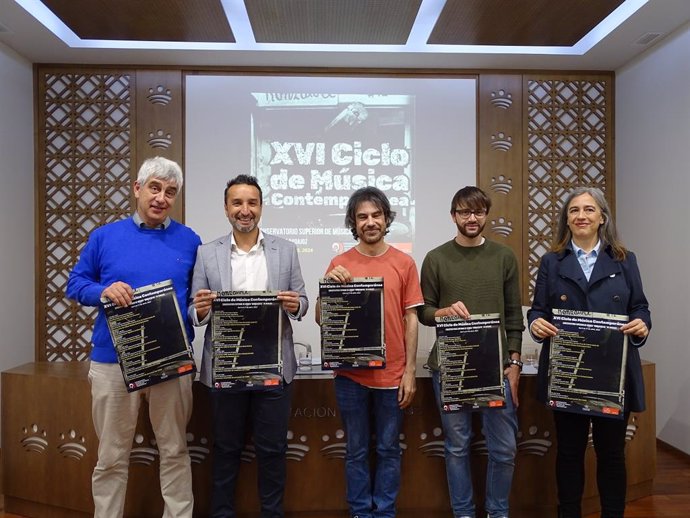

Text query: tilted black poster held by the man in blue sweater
(103, 280), (196, 392)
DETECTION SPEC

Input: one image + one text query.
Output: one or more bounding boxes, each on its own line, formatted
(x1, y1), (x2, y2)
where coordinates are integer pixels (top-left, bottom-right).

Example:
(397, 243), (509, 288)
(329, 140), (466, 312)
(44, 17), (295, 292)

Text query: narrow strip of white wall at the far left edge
(0, 43), (35, 378)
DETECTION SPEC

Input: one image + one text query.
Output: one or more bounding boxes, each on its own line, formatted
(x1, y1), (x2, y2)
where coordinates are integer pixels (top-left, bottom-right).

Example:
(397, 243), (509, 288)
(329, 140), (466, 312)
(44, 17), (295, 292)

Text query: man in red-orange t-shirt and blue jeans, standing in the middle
(316, 187), (424, 518)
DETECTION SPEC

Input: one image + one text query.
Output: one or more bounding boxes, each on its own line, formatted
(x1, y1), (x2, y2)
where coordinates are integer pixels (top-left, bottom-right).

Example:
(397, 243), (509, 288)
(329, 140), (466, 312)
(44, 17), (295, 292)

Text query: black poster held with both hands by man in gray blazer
(210, 291), (283, 390)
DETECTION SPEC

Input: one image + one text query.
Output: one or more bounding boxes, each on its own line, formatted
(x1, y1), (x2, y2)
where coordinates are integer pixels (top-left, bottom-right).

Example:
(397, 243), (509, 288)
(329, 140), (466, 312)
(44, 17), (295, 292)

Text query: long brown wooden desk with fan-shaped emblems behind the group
(2, 362), (656, 518)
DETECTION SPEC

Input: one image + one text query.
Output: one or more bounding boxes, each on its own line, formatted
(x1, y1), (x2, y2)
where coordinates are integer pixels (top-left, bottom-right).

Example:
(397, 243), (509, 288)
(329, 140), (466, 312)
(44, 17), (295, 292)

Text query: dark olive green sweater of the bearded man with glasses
(418, 239), (525, 370)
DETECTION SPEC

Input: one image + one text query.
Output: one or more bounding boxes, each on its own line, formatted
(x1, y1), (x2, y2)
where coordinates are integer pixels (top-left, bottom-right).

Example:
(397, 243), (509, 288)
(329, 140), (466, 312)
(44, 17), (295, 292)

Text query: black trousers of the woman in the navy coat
(553, 411), (630, 518)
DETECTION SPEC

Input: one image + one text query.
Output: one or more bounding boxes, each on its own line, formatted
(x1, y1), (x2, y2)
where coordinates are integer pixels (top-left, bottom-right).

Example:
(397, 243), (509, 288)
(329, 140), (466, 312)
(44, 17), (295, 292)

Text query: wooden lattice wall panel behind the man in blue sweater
(36, 72), (132, 361)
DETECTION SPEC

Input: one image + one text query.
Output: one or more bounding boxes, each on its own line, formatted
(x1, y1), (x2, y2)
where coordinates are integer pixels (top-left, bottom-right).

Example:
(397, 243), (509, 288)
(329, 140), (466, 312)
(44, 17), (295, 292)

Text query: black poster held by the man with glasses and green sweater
(436, 313), (505, 412)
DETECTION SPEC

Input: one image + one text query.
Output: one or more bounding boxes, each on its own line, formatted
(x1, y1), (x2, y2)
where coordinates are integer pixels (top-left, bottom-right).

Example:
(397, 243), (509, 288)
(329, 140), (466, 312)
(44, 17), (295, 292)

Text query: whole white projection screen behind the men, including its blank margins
(183, 73), (477, 364)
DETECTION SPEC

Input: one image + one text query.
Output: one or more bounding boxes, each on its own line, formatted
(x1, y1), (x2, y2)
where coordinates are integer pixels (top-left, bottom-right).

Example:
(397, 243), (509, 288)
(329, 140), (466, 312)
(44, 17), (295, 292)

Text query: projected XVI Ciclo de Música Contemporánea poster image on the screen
(251, 92), (415, 254)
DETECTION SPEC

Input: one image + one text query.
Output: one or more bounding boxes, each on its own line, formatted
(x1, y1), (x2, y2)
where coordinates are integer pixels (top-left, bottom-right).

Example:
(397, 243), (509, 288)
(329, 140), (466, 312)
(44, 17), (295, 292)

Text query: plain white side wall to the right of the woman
(616, 24), (690, 453)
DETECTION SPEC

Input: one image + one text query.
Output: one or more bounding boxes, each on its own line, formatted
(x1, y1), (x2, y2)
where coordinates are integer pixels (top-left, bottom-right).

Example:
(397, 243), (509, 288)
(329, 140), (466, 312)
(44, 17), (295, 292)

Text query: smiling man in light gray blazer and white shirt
(189, 175), (309, 518)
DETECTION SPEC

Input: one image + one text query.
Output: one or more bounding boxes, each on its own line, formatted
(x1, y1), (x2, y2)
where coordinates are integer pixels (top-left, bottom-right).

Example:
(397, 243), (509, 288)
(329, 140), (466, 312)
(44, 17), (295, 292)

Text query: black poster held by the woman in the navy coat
(548, 309), (628, 418)
